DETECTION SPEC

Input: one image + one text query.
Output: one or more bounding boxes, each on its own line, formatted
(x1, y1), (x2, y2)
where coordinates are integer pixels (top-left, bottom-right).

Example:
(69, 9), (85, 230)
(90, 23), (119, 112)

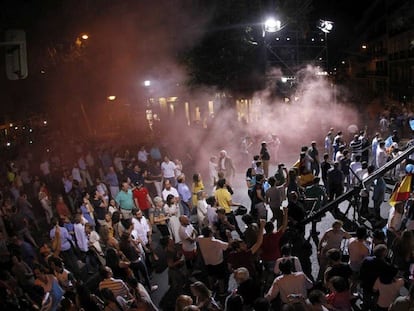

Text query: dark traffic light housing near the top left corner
(0, 30), (28, 80)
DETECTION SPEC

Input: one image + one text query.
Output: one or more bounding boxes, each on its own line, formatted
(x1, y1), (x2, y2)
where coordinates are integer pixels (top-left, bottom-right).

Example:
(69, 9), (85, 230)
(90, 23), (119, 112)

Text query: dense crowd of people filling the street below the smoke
(0, 117), (414, 311)
